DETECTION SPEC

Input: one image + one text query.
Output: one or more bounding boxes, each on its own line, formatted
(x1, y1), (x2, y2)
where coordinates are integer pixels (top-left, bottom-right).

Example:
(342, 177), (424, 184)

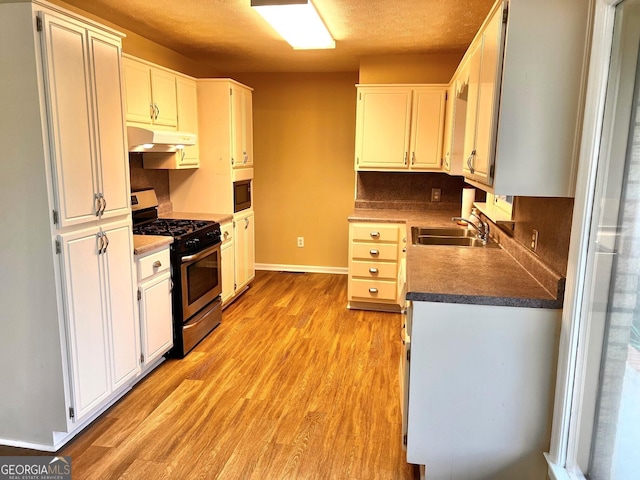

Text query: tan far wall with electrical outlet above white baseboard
(235, 72), (358, 267)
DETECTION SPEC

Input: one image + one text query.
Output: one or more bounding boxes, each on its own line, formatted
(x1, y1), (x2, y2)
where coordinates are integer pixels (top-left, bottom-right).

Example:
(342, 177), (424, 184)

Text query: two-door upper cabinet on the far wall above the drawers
(355, 85), (446, 171)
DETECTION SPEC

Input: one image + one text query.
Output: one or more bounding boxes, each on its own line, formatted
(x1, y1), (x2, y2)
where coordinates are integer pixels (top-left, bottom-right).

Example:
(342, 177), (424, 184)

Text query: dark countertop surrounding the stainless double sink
(349, 209), (564, 309)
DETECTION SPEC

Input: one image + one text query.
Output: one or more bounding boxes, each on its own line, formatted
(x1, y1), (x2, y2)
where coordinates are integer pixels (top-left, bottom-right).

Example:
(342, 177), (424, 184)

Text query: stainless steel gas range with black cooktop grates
(131, 189), (222, 358)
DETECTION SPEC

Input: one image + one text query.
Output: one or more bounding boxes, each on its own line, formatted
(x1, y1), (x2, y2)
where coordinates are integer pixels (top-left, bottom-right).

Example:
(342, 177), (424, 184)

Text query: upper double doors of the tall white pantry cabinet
(41, 13), (129, 227)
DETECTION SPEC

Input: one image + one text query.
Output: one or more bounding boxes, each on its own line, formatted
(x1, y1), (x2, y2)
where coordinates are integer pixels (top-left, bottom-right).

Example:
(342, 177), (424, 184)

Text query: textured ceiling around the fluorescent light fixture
(64, 0), (494, 72)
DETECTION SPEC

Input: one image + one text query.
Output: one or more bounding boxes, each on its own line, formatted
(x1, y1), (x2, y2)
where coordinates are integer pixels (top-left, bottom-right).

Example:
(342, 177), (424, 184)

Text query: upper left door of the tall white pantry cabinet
(42, 14), (98, 227)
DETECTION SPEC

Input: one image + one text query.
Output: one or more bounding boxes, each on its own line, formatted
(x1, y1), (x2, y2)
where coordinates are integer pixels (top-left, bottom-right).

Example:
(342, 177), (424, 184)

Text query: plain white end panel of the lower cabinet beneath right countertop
(401, 302), (562, 480)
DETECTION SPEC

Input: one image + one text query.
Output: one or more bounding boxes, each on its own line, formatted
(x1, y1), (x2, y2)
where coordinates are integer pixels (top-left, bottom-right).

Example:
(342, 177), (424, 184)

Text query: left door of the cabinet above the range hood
(122, 58), (153, 124)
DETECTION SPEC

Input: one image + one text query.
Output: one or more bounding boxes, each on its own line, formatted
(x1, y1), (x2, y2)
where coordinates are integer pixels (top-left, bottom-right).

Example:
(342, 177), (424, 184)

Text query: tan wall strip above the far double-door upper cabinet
(359, 52), (464, 84)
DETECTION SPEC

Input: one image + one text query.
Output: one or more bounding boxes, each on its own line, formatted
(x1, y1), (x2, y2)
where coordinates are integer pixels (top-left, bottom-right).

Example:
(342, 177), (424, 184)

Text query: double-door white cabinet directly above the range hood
(122, 57), (178, 130)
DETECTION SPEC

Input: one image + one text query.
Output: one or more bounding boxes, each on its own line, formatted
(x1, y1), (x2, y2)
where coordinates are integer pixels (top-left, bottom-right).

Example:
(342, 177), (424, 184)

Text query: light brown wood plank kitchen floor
(0, 272), (417, 480)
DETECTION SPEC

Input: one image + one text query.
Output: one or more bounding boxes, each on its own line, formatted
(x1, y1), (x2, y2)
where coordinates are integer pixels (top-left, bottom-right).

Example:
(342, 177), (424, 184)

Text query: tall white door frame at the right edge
(545, 0), (623, 480)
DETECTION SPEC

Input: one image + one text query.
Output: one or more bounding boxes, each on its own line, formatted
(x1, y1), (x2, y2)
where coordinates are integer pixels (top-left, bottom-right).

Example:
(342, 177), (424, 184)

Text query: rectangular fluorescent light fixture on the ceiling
(251, 0), (336, 50)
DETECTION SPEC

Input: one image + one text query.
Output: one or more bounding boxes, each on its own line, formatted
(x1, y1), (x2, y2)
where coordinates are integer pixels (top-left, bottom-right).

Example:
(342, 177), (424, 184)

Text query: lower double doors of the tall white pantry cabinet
(58, 220), (140, 421)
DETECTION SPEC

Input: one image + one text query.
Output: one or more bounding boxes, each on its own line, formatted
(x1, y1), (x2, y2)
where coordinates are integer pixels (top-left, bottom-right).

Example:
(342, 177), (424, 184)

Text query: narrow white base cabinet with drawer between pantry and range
(136, 246), (173, 371)
